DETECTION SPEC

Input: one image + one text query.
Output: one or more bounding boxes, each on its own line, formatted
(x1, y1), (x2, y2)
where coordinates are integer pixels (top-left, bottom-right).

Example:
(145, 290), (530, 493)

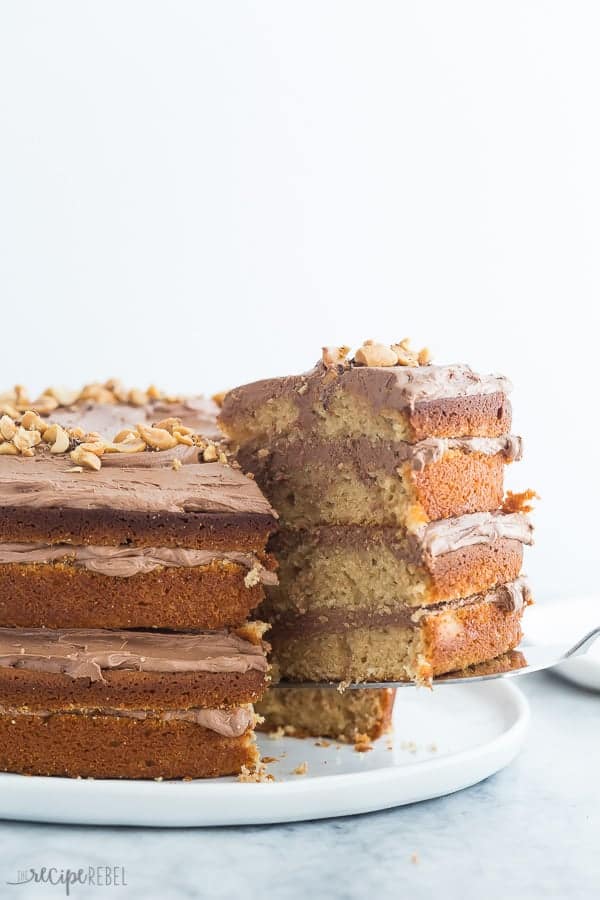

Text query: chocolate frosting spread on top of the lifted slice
(219, 363), (512, 426)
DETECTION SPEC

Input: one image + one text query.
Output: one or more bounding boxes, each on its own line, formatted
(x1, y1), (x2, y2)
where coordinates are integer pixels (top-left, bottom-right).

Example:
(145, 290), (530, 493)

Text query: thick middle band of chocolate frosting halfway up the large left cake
(0, 628), (268, 681)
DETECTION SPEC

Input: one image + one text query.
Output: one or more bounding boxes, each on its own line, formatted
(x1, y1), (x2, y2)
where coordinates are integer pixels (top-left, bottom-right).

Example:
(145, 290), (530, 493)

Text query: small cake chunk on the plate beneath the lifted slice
(256, 688), (395, 741)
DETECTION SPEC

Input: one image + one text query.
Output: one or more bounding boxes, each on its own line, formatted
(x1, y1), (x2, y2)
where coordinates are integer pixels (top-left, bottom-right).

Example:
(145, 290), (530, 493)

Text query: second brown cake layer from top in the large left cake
(0, 554), (270, 631)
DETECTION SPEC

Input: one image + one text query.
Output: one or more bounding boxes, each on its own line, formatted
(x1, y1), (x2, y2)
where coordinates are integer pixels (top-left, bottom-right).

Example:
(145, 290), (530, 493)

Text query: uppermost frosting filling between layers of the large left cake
(0, 544), (277, 585)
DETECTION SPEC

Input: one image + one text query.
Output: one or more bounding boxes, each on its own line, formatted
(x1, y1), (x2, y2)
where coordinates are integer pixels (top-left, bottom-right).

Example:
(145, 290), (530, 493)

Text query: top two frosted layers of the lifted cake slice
(219, 346), (521, 530)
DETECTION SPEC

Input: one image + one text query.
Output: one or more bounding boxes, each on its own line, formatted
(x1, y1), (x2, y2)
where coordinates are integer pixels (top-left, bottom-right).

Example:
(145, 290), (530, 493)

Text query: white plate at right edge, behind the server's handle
(525, 597), (600, 691)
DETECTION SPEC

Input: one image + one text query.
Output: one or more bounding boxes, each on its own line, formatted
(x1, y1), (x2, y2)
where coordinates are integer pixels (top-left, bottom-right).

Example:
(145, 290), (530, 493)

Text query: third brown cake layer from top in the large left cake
(0, 666), (268, 710)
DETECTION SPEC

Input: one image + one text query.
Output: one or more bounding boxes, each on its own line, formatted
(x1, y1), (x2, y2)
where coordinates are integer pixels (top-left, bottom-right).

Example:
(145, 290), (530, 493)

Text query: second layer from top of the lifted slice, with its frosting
(238, 435), (521, 527)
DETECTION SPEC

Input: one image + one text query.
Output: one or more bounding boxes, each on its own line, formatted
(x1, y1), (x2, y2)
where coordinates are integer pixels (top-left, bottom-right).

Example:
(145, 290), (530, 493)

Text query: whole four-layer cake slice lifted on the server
(220, 341), (532, 681)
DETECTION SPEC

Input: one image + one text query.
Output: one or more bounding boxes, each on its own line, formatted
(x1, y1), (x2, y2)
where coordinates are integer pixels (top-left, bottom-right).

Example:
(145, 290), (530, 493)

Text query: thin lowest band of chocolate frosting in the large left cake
(0, 706), (254, 737)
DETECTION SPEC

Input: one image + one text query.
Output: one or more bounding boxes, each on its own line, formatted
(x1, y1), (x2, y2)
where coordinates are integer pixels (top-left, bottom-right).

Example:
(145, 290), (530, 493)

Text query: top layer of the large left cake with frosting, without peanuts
(0, 453), (276, 552)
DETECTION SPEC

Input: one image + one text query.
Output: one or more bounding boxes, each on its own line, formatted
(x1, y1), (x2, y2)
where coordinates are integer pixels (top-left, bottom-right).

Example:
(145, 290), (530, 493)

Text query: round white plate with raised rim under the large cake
(0, 681), (529, 826)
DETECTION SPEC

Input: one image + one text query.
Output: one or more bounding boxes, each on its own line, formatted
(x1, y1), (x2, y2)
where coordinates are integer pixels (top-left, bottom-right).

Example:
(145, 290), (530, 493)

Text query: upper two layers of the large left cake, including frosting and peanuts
(0, 411), (276, 630)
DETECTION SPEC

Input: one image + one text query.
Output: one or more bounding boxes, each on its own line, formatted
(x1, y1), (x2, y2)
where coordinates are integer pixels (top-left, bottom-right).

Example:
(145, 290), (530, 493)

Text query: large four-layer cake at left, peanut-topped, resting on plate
(0, 404), (276, 778)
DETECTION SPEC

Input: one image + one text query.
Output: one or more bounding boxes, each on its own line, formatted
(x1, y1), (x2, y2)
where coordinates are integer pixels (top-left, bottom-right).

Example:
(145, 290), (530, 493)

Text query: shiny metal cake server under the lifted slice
(271, 625), (600, 690)
